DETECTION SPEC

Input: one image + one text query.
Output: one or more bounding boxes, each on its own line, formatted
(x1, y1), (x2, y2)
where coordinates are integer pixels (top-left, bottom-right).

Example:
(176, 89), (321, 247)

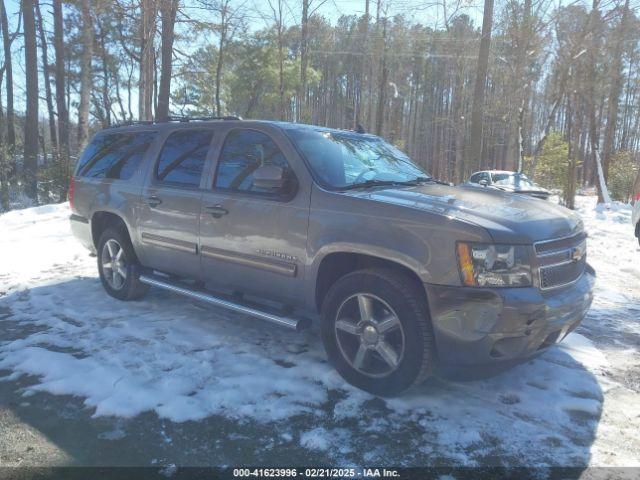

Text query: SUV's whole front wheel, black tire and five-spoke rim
(322, 269), (435, 396)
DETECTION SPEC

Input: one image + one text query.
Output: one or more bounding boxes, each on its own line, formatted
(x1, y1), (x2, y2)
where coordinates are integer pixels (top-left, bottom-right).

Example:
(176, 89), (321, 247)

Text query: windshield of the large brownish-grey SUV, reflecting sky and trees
(287, 129), (430, 189)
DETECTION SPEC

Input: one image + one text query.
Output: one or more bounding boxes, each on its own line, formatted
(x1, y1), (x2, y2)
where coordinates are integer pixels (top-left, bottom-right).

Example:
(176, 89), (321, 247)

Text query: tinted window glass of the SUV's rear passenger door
(156, 130), (213, 187)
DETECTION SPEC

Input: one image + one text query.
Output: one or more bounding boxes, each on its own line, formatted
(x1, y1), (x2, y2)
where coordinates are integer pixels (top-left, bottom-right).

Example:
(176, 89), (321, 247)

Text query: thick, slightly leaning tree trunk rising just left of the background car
(465, 0), (493, 173)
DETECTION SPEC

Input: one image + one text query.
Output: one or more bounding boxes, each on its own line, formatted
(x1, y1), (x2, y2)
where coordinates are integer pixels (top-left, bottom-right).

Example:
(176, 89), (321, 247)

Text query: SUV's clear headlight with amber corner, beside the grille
(456, 242), (531, 287)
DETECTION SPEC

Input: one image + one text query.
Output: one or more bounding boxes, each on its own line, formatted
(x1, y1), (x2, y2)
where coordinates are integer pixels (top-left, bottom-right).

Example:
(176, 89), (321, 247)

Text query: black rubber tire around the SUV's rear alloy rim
(96, 227), (149, 300)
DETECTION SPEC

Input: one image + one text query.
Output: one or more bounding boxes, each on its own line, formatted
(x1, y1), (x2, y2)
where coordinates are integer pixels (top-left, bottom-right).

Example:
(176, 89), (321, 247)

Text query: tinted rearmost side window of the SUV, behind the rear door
(77, 132), (157, 180)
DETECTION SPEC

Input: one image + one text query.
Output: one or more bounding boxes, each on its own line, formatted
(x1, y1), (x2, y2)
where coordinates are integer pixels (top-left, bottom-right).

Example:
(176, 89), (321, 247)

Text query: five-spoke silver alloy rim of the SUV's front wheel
(335, 293), (405, 378)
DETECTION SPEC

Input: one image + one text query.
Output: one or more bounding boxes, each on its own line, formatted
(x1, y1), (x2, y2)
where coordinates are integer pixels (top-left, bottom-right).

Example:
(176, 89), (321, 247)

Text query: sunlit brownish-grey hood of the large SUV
(345, 184), (583, 244)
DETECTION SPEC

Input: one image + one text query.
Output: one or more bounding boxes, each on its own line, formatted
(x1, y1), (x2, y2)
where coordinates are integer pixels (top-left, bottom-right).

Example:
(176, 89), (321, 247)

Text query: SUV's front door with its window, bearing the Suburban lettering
(200, 124), (309, 304)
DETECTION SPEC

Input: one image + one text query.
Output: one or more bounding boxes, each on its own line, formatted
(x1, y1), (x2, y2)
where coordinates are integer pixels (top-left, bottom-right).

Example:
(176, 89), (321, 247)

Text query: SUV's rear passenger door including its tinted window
(138, 128), (214, 278)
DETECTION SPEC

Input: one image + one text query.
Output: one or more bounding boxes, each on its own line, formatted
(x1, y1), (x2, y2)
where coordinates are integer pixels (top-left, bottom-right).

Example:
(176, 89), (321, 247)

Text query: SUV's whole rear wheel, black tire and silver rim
(97, 227), (149, 300)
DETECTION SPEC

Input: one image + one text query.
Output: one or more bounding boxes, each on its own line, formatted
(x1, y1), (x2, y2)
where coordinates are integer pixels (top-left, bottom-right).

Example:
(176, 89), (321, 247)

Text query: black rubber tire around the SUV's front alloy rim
(321, 268), (436, 396)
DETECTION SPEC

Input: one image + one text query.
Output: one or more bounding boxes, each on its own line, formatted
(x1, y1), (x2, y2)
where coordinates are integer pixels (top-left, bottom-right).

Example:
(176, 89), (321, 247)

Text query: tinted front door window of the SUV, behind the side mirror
(215, 130), (289, 193)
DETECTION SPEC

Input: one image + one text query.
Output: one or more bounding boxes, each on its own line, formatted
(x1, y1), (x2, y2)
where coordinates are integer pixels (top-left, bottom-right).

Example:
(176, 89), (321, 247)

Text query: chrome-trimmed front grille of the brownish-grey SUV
(534, 233), (587, 290)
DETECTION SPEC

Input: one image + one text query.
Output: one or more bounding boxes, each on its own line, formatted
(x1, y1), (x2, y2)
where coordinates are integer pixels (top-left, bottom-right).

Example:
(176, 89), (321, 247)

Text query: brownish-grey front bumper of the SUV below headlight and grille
(425, 265), (595, 371)
